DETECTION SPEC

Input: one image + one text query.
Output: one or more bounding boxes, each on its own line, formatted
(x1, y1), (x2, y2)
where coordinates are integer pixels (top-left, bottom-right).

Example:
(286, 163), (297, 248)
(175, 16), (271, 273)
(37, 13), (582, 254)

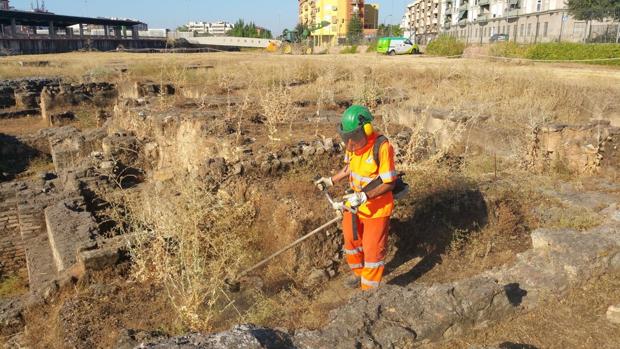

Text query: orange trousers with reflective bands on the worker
(342, 211), (390, 290)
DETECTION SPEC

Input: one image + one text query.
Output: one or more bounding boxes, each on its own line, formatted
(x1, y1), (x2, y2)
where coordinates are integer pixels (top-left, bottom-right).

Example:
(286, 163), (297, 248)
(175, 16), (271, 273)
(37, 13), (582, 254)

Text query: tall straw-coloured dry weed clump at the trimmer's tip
(101, 178), (254, 331)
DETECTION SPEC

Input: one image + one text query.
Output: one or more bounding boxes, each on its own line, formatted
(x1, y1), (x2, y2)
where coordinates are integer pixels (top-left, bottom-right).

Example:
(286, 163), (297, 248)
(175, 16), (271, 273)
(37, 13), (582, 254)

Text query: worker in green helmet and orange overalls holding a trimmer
(315, 105), (398, 290)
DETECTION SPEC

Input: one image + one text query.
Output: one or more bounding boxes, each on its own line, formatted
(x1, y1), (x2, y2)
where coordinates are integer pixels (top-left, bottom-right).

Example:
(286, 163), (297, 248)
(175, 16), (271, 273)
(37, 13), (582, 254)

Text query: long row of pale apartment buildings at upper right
(401, 0), (620, 44)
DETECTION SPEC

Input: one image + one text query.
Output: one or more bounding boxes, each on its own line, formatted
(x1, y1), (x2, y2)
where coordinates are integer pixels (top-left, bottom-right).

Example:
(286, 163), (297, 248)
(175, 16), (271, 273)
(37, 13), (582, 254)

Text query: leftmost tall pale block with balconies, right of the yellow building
(401, 0), (440, 44)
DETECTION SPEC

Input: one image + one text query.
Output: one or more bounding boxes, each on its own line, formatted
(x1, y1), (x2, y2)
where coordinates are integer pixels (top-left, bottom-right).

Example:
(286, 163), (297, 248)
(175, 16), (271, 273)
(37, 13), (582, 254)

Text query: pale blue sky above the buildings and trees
(10, 0), (412, 35)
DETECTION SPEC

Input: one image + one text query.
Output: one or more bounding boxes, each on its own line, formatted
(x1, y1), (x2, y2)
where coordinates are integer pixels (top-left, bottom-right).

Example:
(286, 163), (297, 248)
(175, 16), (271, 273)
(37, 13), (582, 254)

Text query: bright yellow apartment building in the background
(298, 0), (365, 46)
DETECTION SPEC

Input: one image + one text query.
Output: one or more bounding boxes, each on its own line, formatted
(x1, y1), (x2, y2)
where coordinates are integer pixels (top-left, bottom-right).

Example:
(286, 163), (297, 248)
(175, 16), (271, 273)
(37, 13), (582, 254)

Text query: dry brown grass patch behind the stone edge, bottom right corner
(424, 273), (620, 349)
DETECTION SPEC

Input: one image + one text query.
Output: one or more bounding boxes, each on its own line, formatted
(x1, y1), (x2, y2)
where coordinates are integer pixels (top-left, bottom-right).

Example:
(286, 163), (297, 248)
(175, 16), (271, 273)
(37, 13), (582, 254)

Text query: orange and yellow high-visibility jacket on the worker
(344, 133), (398, 219)
